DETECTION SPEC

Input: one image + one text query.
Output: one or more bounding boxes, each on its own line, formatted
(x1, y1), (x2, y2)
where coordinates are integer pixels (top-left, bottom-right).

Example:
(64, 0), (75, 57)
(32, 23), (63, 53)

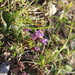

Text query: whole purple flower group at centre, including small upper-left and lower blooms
(24, 28), (48, 51)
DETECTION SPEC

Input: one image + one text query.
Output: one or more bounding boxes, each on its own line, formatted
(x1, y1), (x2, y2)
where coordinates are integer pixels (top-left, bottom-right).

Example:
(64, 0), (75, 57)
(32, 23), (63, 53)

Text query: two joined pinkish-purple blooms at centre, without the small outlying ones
(31, 30), (48, 45)
